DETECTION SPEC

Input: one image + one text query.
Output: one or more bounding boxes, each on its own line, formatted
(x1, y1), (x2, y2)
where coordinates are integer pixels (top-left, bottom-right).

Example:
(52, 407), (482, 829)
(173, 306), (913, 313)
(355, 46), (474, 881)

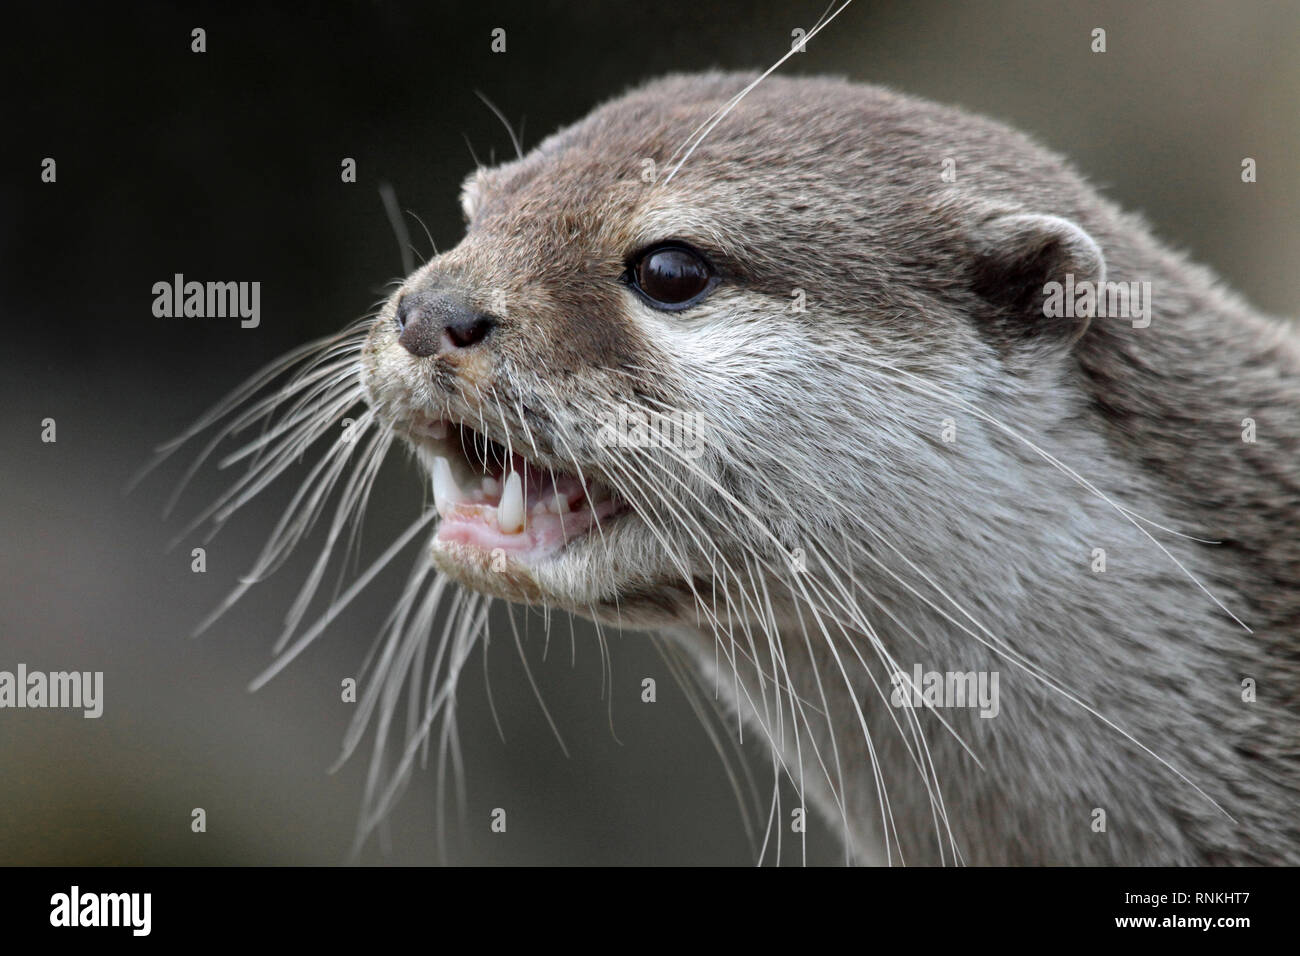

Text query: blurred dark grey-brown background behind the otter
(0, 0), (1300, 865)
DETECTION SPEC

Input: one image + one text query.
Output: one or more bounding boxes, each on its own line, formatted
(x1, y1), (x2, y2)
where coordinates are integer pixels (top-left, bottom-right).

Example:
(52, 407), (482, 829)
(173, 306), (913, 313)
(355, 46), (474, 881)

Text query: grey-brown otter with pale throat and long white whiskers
(165, 73), (1300, 864)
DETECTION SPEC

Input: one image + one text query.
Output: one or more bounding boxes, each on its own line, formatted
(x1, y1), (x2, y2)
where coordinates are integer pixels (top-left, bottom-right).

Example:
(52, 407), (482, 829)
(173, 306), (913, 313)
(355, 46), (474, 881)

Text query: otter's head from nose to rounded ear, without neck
(363, 74), (1100, 623)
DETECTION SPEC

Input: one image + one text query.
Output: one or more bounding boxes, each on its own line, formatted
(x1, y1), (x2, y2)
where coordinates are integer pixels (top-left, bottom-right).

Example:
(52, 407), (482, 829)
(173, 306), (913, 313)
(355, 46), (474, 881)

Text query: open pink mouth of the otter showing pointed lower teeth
(408, 419), (629, 563)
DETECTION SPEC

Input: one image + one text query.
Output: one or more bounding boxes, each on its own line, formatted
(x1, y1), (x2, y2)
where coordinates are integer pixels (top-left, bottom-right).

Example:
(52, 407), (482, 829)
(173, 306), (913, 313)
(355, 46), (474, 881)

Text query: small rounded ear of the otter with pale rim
(971, 213), (1106, 349)
